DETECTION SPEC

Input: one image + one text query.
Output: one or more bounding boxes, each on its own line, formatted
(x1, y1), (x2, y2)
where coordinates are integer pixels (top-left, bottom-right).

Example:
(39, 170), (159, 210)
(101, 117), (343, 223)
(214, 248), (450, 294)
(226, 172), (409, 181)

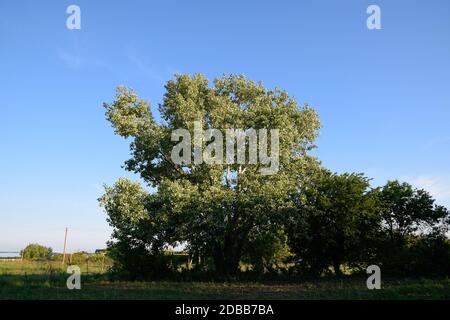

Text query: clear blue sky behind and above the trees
(0, 0), (450, 251)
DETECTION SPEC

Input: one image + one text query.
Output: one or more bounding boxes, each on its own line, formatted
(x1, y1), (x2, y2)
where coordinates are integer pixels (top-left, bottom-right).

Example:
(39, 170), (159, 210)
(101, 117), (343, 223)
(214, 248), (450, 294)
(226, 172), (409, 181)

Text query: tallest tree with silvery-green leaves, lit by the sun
(100, 75), (320, 274)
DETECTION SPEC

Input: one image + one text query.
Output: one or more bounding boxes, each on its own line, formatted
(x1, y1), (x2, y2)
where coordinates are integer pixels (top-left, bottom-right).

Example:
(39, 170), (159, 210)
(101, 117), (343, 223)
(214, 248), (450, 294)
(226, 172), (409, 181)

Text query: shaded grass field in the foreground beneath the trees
(0, 261), (450, 299)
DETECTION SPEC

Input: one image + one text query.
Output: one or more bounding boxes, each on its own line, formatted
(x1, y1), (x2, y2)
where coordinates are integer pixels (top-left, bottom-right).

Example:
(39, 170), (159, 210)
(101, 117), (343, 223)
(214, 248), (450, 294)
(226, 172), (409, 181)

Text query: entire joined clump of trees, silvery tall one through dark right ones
(99, 74), (450, 279)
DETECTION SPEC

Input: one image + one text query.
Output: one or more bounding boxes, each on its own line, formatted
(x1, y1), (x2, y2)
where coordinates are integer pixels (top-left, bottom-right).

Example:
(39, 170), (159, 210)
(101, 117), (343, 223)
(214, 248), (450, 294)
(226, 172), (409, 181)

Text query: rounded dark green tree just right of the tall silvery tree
(287, 170), (380, 274)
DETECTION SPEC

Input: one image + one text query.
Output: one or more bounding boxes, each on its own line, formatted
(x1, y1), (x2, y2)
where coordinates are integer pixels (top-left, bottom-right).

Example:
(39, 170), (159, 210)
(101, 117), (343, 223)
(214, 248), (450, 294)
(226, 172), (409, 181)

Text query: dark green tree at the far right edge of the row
(377, 181), (450, 275)
